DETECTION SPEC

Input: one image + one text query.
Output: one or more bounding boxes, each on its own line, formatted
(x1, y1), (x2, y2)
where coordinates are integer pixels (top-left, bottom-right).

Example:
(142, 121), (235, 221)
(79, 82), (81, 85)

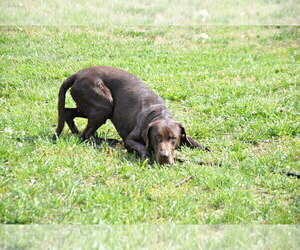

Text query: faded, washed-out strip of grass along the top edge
(0, 0), (300, 26)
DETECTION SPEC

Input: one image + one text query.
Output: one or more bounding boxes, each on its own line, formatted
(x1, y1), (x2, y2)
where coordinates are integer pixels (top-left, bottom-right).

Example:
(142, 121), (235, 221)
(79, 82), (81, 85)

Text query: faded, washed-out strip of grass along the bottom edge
(0, 224), (299, 249)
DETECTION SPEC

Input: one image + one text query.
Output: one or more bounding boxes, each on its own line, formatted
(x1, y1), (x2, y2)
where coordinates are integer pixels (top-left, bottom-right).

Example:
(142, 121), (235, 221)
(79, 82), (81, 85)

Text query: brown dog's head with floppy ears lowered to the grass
(143, 118), (186, 164)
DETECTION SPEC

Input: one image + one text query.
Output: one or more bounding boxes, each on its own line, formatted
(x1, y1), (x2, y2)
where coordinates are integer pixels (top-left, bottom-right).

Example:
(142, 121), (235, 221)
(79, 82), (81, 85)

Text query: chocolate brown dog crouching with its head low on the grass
(53, 66), (202, 164)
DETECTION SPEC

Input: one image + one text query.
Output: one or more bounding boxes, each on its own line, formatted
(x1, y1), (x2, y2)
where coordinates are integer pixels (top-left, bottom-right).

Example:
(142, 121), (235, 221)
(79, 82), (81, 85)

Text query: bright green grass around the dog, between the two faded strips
(0, 26), (300, 224)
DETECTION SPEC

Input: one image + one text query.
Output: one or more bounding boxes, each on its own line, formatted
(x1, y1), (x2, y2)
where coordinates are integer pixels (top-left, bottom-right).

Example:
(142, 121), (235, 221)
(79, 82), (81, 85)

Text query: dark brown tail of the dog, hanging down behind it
(53, 74), (76, 140)
